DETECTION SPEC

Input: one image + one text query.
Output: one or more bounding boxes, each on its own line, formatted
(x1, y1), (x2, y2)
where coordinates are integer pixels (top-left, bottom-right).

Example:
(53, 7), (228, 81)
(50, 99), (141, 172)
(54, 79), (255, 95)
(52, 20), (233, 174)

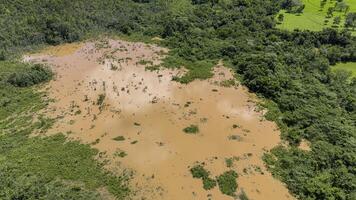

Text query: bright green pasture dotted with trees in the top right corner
(276, 0), (356, 34)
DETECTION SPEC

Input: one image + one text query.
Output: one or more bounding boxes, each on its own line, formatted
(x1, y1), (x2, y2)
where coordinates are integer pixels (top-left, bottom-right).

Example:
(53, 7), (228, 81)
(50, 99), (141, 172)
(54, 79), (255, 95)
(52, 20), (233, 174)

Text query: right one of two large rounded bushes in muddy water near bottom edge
(216, 170), (238, 196)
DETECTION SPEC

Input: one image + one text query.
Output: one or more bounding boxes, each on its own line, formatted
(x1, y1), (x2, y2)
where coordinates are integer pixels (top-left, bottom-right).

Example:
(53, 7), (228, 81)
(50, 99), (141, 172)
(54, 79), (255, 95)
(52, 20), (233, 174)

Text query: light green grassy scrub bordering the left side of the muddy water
(0, 62), (130, 199)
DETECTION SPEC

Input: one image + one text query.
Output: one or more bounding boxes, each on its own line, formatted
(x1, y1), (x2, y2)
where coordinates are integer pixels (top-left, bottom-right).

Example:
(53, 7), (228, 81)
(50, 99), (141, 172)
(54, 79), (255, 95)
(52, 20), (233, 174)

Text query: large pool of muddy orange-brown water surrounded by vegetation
(25, 39), (293, 200)
